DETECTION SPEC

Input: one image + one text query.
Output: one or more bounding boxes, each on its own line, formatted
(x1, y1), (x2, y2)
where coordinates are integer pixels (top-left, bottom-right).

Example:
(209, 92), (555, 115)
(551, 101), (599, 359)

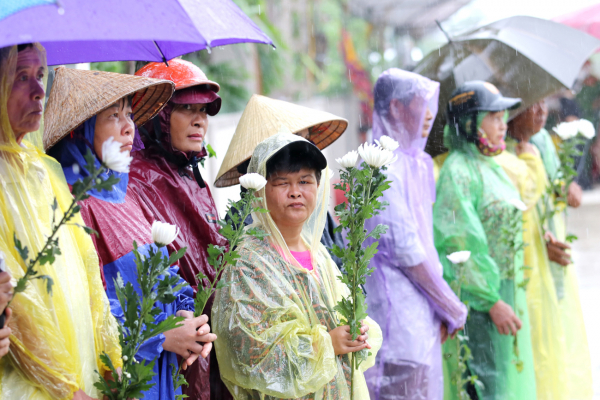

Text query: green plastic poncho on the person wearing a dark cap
(433, 114), (536, 400)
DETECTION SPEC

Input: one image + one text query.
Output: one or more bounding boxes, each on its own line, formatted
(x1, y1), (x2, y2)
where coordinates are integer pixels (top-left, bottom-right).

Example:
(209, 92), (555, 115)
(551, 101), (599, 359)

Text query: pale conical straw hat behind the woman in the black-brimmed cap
(215, 94), (348, 187)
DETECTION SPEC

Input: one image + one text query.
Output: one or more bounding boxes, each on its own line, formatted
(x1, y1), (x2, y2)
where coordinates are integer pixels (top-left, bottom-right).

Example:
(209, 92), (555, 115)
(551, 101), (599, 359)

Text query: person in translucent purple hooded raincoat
(365, 68), (467, 400)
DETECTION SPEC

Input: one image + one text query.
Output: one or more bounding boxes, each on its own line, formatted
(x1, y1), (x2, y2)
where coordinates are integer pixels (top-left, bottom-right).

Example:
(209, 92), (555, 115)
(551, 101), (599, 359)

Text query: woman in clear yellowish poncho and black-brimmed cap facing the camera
(212, 133), (381, 400)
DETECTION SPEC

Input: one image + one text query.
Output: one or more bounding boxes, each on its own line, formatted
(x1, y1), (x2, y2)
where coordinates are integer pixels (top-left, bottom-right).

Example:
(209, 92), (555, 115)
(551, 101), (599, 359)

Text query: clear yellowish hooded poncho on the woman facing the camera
(212, 133), (381, 400)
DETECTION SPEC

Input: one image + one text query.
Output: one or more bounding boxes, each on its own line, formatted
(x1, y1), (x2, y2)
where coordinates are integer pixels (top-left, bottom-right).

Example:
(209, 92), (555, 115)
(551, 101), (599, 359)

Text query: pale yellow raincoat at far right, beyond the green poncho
(496, 139), (592, 400)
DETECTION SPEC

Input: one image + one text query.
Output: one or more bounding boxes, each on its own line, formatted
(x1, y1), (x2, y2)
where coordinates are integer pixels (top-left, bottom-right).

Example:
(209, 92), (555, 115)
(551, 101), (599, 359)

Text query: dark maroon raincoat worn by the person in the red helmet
(128, 117), (231, 400)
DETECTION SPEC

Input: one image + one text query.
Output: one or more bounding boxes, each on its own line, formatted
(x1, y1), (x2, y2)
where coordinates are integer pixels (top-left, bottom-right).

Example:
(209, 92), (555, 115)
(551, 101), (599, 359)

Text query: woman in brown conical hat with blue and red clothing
(45, 68), (215, 400)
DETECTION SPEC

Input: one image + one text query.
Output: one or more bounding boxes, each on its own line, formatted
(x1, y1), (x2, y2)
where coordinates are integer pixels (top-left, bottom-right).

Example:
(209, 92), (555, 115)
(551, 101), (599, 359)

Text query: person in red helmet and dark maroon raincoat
(129, 59), (230, 400)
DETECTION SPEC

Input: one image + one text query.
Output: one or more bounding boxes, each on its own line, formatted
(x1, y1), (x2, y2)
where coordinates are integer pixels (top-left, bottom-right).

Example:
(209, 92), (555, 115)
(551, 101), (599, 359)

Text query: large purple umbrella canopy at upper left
(0, 0), (273, 65)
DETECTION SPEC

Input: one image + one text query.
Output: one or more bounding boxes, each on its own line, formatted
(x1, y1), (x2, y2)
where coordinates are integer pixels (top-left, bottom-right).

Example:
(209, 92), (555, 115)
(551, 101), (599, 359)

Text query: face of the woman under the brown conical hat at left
(94, 99), (135, 159)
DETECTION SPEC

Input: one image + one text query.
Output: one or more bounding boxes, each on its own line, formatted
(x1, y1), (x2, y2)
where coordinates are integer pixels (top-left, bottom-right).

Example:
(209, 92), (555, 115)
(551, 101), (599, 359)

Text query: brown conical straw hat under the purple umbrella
(44, 67), (175, 150)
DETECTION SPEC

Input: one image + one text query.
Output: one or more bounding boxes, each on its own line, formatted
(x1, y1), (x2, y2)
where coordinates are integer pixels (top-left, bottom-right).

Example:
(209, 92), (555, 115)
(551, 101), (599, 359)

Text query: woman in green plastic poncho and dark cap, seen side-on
(433, 81), (536, 400)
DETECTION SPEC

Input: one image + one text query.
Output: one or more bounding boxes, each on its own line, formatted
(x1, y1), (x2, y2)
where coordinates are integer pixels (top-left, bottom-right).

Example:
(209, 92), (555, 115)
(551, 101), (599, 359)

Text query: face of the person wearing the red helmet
(170, 104), (208, 153)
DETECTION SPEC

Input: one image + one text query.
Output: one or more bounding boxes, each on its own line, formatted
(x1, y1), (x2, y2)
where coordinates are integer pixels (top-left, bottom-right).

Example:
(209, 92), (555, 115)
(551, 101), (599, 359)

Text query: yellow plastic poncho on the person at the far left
(0, 45), (121, 400)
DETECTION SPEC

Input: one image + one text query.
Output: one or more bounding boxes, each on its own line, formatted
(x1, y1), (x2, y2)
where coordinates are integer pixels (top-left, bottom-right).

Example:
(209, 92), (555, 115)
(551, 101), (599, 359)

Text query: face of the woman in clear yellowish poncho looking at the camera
(265, 168), (319, 230)
